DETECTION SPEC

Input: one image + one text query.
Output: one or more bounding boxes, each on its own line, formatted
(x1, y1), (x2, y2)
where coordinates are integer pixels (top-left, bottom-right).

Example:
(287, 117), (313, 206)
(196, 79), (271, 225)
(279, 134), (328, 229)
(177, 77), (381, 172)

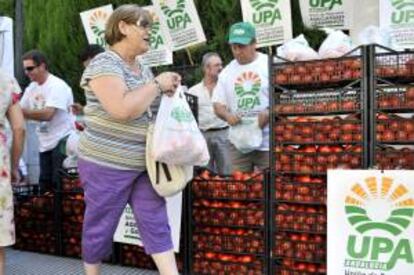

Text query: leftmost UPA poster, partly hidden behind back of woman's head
(80, 4), (113, 47)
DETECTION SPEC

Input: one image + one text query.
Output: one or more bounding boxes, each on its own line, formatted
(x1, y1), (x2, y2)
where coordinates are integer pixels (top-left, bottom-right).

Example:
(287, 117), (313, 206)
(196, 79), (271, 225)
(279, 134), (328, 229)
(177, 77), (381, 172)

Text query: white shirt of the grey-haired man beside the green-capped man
(188, 81), (228, 130)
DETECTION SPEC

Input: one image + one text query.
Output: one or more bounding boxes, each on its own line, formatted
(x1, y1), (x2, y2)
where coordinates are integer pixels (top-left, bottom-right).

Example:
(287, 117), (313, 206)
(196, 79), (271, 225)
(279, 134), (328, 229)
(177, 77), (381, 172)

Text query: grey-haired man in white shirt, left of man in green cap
(188, 52), (231, 175)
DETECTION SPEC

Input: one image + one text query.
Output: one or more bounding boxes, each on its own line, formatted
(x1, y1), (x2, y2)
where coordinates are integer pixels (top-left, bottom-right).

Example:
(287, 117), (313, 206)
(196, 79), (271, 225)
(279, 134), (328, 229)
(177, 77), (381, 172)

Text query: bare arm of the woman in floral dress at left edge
(7, 103), (26, 183)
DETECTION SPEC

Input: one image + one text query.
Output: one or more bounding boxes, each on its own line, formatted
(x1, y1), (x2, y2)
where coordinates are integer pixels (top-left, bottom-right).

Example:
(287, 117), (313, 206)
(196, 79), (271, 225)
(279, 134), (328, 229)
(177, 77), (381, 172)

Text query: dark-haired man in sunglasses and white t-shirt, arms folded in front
(20, 50), (74, 192)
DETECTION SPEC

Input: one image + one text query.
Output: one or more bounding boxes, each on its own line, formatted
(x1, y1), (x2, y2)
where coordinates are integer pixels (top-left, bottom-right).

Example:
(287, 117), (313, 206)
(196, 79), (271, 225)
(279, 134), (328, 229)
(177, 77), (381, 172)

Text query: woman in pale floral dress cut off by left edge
(0, 71), (25, 274)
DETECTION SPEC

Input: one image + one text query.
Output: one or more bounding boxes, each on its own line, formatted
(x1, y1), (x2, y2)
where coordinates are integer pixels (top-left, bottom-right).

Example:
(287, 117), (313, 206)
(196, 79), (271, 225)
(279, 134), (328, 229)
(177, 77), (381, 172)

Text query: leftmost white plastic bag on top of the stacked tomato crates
(277, 34), (319, 61)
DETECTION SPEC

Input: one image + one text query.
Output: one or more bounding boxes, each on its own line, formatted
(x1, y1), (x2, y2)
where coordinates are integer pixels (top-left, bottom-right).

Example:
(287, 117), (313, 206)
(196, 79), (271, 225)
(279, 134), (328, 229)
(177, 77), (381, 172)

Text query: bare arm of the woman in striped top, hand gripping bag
(89, 72), (181, 121)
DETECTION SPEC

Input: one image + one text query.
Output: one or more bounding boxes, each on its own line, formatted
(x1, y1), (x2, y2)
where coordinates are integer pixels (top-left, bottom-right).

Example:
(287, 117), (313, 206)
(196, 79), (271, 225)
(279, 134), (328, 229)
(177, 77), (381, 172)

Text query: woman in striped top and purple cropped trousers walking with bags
(78, 5), (181, 275)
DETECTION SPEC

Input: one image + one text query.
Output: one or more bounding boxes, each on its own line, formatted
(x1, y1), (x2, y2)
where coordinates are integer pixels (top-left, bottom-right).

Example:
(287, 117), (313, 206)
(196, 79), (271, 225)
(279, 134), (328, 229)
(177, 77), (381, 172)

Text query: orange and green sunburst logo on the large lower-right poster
(345, 177), (414, 236)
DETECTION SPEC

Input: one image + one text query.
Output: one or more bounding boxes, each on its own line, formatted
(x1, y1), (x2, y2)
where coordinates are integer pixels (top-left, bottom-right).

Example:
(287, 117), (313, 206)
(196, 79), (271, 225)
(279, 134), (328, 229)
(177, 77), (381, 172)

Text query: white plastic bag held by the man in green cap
(229, 116), (263, 154)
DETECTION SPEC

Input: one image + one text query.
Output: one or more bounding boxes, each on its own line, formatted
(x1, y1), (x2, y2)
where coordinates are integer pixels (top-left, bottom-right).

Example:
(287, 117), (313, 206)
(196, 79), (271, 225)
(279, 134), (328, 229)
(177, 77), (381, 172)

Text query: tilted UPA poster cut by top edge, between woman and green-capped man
(152, 0), (206, 51)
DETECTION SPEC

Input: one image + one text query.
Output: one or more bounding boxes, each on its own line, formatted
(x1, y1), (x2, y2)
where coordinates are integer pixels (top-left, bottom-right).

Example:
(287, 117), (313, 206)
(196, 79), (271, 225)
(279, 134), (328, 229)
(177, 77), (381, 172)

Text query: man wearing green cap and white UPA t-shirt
(212, 22), (269, 172)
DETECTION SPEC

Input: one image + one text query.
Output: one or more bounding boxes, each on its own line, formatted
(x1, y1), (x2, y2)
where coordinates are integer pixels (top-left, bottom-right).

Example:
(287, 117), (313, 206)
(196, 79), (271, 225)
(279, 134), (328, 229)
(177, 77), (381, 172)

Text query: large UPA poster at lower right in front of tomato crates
(328, 170), (414, 275)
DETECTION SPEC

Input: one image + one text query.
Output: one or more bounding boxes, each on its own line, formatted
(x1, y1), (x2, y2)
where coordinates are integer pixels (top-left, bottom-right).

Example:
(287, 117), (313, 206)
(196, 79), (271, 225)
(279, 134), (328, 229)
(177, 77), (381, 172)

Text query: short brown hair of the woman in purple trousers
(105, 4), (152, 45)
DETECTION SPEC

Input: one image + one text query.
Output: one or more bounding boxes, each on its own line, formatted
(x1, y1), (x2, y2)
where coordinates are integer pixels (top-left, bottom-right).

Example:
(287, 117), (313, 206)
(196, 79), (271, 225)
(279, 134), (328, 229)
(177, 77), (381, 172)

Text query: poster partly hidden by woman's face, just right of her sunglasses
(139, 6), (173, 67)
